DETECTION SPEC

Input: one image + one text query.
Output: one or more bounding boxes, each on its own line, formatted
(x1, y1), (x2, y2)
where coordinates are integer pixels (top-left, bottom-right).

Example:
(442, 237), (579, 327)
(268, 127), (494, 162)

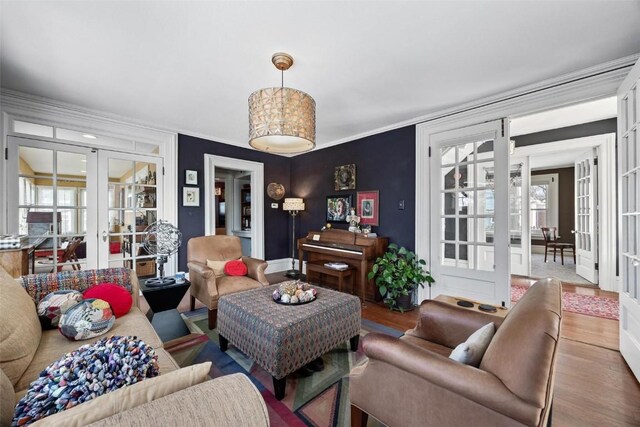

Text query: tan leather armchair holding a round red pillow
(187, 236), (269, 329)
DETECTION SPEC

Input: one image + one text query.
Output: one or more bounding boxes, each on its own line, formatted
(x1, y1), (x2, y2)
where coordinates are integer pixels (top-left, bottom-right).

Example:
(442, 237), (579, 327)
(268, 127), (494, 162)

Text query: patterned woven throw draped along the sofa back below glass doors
(21, 268), (132, 305)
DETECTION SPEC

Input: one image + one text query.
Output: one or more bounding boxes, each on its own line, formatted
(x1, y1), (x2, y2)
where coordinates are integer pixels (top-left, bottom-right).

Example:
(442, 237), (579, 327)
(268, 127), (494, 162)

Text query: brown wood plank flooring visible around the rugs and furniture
(168, 273), (640, 427)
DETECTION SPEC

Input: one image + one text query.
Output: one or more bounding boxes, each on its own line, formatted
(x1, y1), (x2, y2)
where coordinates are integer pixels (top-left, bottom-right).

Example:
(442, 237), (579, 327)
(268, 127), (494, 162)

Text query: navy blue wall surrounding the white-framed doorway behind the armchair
(178, 135), (291, 271)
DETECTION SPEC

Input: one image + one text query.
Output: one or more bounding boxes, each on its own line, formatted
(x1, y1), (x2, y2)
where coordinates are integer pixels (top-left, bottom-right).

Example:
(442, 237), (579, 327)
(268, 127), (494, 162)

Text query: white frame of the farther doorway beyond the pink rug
(514, 133), (619, 292)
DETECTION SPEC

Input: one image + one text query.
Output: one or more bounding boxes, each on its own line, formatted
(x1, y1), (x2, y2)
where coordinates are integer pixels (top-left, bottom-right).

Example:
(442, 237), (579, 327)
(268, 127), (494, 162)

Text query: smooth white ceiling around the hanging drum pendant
(0, 0), (640, 148)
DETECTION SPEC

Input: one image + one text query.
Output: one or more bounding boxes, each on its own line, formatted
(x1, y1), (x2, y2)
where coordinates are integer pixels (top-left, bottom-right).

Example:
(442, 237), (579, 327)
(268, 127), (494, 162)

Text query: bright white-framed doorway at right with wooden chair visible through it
(512, 134), (616, 290)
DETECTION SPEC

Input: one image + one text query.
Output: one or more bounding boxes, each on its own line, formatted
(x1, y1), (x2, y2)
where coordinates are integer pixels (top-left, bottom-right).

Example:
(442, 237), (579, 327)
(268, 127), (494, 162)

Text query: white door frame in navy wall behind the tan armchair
(204, 154), (265, 259)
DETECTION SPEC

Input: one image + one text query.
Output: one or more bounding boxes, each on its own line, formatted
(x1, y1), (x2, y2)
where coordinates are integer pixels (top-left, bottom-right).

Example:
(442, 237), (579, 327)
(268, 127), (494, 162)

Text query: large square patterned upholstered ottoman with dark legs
(218, 286), (360, 400)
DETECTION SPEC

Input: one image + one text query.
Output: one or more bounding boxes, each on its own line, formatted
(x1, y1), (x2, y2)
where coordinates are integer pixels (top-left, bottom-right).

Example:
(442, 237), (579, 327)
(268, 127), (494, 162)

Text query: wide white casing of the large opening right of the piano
(415, 67), (637, 302)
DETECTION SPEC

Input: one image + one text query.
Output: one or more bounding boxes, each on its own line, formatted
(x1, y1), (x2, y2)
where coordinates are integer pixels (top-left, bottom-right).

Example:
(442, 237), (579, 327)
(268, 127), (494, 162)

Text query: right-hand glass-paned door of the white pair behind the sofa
(99, 151), (163, 278)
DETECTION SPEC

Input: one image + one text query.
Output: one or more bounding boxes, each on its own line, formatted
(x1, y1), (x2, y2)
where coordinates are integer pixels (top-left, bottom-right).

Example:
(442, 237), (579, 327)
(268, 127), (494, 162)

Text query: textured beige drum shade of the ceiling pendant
(249, 87), (316, 154)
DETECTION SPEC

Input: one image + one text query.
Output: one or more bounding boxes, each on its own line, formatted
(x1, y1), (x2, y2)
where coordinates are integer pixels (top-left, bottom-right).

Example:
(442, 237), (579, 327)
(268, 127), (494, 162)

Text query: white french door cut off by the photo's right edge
(618, 57), (640, 380)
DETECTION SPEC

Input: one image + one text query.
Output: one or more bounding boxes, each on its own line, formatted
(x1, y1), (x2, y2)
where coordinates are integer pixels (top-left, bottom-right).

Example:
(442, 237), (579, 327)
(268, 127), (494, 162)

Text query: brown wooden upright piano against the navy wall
(298, 230), (389, 302)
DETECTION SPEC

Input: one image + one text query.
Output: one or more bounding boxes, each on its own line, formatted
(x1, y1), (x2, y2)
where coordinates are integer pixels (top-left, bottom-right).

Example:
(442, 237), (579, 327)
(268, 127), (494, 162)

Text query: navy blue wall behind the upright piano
(289, 126), (416, 249)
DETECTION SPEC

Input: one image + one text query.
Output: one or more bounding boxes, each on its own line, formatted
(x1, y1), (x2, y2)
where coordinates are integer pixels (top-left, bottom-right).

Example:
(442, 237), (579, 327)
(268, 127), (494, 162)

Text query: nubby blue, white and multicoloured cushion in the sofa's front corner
(13, 336), (158, 425)
